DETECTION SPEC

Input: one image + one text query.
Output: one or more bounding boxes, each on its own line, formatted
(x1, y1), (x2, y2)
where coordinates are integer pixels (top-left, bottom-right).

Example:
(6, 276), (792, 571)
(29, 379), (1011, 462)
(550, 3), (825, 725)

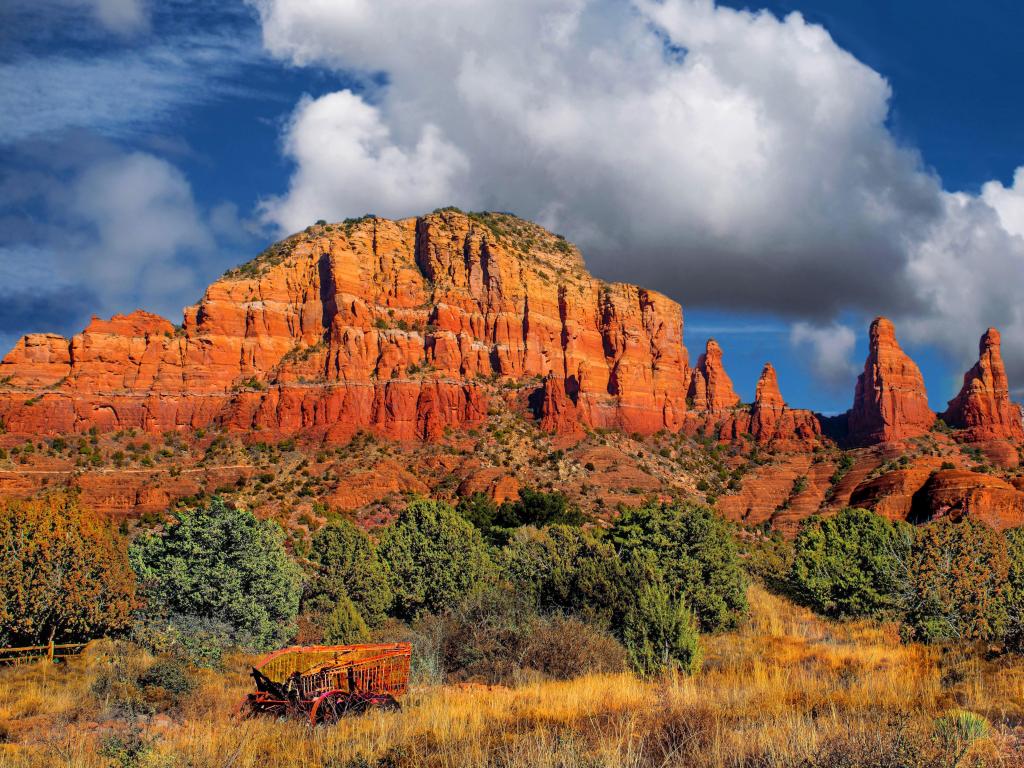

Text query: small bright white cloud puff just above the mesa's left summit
(262, 90), (466, 229)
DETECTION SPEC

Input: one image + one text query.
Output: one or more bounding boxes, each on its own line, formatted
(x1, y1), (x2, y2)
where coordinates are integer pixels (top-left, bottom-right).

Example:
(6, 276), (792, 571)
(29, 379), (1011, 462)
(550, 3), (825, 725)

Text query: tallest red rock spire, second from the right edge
(848, 317), (935, 445)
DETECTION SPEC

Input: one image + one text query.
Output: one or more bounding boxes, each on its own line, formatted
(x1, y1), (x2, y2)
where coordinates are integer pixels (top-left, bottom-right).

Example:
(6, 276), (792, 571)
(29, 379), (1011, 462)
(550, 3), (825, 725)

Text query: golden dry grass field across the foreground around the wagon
(0, 588), (1024, 768)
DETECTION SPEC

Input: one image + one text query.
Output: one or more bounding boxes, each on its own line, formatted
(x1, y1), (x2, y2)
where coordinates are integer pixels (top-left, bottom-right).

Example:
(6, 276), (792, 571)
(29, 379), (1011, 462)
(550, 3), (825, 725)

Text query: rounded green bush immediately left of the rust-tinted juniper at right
(790, 508), (910, 616)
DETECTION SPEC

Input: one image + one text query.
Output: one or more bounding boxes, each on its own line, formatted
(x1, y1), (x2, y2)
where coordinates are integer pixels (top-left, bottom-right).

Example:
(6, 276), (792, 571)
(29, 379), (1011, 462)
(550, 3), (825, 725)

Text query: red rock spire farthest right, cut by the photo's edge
(942, 328), (1024, 441)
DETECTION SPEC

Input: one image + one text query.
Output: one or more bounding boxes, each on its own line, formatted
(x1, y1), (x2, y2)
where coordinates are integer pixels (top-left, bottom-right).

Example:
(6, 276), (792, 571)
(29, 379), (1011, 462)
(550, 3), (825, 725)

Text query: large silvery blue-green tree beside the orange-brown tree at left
(131, 498), (301, 650)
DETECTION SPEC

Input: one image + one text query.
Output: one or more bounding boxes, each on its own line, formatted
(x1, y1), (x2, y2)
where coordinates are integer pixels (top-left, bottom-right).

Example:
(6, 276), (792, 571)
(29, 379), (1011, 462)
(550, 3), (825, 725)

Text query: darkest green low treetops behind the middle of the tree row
(458, 487), (585, 545)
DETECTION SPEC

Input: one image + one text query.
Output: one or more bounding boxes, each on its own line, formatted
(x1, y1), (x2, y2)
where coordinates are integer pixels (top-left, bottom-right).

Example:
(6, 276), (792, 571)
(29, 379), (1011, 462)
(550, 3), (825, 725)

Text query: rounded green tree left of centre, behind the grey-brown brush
(378, 499), (494, 621)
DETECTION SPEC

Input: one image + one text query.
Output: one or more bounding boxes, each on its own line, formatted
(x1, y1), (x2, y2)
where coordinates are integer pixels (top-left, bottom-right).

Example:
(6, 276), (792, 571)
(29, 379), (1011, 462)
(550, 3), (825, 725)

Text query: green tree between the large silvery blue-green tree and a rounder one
(303, 520), (394, 627)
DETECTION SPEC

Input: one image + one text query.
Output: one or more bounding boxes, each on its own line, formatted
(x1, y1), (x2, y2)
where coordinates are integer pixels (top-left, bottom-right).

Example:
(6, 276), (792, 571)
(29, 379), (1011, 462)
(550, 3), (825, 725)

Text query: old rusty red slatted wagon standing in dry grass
(240, 643), (413, 725)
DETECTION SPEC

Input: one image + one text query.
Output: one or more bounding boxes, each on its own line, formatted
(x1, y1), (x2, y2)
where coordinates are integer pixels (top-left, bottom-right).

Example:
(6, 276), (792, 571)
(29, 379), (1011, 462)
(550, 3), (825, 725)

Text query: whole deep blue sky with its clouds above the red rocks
(0, 0), (1024, 413)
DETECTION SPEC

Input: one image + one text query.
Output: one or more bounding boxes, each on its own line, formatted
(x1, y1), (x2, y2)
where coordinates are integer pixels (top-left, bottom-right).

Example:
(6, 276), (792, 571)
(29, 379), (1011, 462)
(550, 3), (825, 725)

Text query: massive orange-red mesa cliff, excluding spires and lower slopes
(0, 210), (688, 441)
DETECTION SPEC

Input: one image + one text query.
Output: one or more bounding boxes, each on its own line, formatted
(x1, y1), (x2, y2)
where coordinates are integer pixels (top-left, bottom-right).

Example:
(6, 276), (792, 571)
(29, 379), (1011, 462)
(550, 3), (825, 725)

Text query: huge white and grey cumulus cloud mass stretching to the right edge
(245, 0), (1024, 387)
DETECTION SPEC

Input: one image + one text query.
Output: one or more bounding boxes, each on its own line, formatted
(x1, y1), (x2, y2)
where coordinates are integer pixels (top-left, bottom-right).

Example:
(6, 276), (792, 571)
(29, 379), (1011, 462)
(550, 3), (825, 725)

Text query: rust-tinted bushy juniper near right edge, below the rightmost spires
(907, 519), (1010, 641)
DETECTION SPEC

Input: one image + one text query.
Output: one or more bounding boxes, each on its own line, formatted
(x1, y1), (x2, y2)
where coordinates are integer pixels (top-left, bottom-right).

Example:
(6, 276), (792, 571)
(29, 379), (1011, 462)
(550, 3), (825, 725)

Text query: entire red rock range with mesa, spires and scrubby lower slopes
(0, 209), (1024, 529)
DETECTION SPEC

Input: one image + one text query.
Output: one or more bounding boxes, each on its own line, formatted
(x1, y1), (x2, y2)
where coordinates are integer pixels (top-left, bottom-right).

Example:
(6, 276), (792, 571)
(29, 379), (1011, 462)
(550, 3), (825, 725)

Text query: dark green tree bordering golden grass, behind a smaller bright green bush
(609, 504), (748, 632)
